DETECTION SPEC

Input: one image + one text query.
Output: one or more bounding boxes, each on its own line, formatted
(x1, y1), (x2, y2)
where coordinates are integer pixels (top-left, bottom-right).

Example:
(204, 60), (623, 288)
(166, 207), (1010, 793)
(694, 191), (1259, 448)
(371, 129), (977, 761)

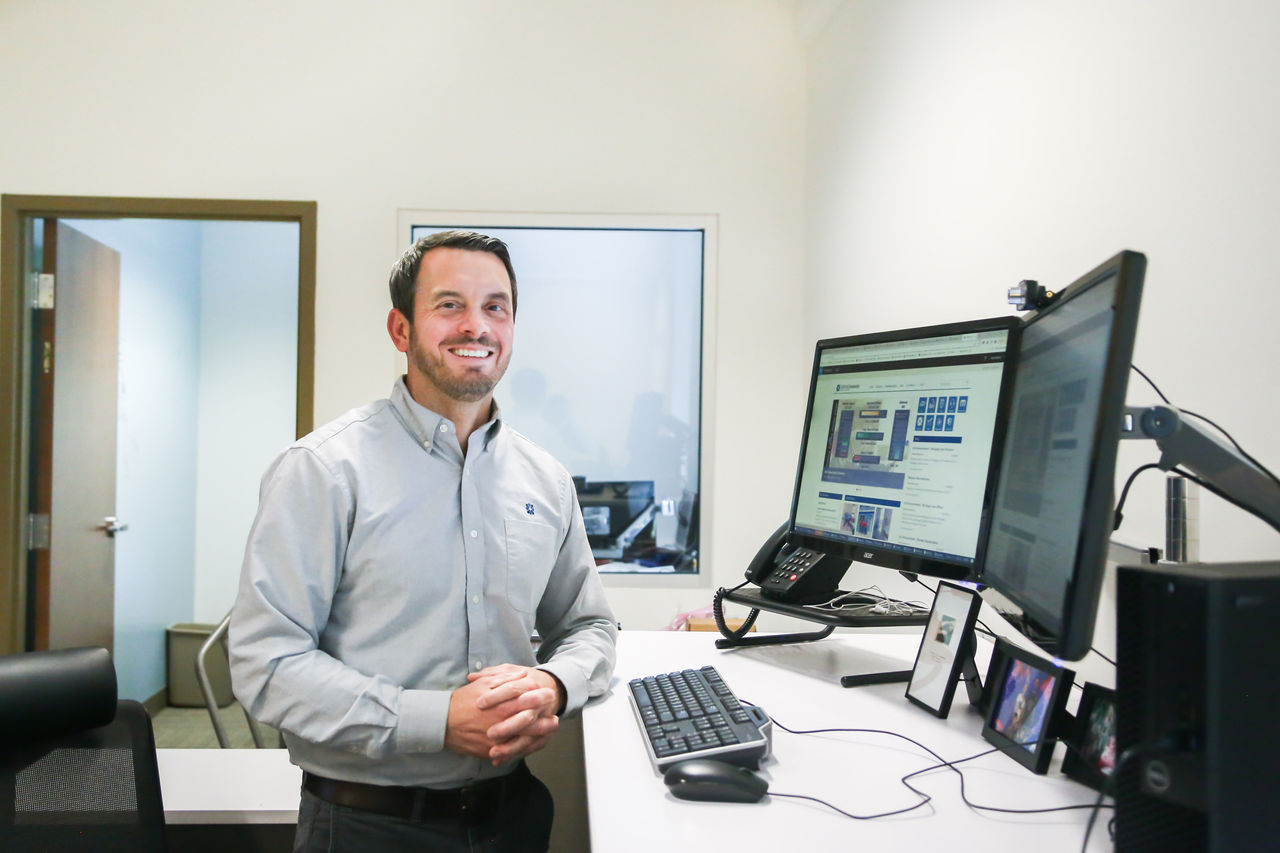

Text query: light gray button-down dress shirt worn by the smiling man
(229, 378), (617, 788)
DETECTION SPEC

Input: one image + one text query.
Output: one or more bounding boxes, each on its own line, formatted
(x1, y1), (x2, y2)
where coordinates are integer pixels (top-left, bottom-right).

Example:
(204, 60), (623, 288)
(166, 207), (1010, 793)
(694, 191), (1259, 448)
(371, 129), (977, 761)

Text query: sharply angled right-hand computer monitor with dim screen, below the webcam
(980, 245), (1147, 661)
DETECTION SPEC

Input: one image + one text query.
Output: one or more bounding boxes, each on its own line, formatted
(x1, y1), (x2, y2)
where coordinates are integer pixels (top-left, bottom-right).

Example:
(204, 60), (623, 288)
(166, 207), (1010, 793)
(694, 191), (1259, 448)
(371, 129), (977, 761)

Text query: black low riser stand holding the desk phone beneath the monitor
(714, 587), (931, 689)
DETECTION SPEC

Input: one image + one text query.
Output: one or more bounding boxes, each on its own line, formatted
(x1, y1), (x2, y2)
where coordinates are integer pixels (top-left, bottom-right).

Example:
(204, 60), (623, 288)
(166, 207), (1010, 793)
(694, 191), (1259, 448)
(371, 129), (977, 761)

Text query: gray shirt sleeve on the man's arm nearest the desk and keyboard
(536, 474), (618, 713)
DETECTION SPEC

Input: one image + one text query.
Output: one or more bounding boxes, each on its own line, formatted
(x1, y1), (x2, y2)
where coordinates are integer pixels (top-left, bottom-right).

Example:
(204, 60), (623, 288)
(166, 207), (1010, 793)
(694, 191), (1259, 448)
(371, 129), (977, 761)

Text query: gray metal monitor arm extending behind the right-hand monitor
(1120, 406), (1280, 530)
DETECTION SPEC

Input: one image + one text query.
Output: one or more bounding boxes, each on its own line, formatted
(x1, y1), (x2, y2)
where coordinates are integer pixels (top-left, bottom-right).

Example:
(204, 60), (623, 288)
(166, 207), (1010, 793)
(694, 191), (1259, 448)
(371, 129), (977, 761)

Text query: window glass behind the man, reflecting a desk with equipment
(411, 222), (704, 573)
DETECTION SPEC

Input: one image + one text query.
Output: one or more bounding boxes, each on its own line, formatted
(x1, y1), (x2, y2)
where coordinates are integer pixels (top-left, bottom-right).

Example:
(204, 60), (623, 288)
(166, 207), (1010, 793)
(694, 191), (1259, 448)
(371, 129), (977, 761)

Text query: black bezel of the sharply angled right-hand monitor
(978, 250), (1147, 661)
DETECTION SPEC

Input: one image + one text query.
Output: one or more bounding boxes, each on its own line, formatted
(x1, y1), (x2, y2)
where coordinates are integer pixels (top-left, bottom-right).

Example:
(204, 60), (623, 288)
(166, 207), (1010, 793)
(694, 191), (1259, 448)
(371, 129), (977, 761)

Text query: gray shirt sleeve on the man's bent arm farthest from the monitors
(228, 446), (449, 758)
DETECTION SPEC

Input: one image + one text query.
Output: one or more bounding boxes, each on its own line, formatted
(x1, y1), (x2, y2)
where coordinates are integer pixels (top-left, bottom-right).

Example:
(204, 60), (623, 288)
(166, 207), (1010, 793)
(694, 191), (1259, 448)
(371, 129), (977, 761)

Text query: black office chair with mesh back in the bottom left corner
(0, 648), (165, 853)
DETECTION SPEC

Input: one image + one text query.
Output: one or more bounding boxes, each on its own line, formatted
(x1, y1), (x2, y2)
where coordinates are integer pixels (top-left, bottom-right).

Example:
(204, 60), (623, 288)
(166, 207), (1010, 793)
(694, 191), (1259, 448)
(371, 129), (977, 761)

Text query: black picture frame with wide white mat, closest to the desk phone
(906, 581), (982, 717)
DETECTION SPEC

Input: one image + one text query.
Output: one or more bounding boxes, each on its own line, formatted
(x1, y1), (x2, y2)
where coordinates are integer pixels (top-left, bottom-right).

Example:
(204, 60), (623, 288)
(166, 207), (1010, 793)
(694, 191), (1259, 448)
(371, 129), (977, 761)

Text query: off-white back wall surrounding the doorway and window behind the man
(0, 0), (809, 628)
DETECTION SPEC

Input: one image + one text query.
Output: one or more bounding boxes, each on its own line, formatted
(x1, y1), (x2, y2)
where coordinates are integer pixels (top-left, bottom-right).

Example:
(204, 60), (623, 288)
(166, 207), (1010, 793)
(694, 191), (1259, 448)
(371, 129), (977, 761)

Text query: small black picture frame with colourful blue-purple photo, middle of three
(982, 639), (1075, 774)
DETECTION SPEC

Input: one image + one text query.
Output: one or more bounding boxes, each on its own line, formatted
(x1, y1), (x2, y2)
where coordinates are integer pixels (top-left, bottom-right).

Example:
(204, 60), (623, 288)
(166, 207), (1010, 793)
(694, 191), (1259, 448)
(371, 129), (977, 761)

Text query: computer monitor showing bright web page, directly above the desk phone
(787, 316), (1020, 580)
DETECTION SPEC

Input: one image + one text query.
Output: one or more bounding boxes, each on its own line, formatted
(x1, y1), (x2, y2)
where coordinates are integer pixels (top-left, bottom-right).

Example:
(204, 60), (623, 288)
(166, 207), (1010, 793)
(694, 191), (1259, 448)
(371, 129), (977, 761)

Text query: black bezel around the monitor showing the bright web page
(787, 315), (1023, 580)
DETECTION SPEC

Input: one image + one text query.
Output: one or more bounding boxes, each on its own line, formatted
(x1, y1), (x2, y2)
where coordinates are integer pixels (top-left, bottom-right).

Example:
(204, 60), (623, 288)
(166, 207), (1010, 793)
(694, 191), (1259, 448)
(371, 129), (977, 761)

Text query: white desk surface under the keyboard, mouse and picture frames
(582, 631), (1112, 853)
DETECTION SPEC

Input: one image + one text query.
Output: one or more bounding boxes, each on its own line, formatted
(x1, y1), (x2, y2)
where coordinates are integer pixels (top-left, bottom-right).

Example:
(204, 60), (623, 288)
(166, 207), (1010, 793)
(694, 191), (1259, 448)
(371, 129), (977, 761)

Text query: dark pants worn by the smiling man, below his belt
(293, 768), (553, 853)
